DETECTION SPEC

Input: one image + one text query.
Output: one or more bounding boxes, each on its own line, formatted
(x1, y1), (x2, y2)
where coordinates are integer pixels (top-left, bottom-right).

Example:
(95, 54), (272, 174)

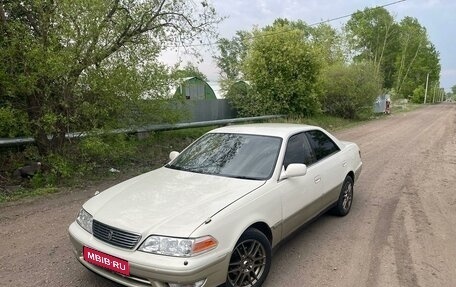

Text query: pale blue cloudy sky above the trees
(162, 0), (456, 92)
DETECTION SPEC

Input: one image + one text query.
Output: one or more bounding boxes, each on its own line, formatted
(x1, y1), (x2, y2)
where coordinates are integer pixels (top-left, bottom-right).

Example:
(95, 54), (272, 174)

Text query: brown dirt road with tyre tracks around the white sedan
(0, 104), (456, 287)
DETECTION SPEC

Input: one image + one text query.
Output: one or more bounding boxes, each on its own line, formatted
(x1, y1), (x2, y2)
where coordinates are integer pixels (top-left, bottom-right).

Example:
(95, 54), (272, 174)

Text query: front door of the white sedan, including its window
(278, 133), (323, 237)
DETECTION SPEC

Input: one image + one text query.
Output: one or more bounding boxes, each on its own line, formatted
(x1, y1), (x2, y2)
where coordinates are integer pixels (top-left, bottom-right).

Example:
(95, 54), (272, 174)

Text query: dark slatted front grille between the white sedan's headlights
(92, 220), (141, 249)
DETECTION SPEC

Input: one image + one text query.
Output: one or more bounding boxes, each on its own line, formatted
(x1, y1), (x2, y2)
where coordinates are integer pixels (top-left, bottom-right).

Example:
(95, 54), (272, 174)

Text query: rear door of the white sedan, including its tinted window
(306, 130), (347, 207)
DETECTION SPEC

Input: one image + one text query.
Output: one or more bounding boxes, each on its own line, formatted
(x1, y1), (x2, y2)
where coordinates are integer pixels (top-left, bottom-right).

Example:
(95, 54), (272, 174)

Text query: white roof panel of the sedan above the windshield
(210, 123), (320, 138)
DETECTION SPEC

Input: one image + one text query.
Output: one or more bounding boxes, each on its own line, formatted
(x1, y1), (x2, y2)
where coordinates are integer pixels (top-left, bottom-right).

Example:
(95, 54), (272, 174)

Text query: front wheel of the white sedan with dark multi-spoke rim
(226, 228), (272, 287)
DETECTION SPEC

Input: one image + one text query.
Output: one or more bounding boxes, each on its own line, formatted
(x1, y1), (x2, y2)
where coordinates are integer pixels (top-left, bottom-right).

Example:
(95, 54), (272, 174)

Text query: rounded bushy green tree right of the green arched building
(242, 25), (321, 115)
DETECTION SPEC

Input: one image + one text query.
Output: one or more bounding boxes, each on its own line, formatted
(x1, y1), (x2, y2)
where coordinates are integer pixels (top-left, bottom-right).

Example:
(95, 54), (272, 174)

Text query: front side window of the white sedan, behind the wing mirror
(283, 133), (315, 169)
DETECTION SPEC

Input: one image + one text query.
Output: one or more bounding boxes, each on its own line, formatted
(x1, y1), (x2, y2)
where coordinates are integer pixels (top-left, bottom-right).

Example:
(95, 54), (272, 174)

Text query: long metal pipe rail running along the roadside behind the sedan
(0, 115), (283, 147)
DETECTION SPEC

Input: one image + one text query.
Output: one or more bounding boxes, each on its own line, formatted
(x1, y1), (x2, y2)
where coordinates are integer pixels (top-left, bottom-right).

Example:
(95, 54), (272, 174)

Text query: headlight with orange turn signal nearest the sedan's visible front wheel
(138, 235), (218, 257)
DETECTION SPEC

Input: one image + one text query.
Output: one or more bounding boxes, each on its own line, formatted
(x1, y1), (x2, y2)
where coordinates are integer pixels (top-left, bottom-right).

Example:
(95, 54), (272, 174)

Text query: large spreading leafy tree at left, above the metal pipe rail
(0, 0), (219, 154)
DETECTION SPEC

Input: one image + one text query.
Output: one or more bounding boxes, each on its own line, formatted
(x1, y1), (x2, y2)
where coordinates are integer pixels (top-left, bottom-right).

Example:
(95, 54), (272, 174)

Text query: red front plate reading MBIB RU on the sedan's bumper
(83, 246), (130, 276)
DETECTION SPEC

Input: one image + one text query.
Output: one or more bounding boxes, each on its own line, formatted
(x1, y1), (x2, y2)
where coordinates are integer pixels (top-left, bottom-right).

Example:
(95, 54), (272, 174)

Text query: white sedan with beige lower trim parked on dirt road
(69, 124), (362, 287)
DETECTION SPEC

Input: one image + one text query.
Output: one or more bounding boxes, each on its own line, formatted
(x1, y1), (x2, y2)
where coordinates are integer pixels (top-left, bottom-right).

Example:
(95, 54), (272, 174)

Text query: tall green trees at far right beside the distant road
(345, 7), (441, 100)
